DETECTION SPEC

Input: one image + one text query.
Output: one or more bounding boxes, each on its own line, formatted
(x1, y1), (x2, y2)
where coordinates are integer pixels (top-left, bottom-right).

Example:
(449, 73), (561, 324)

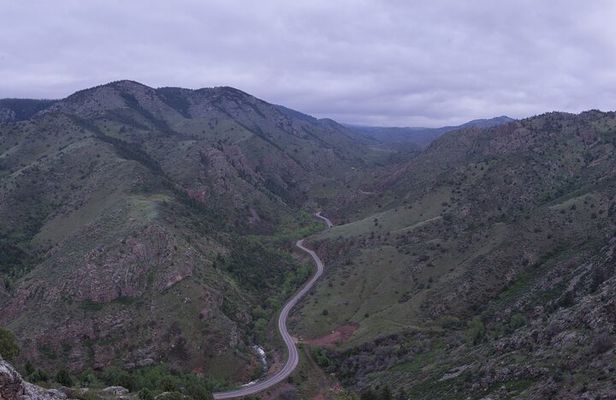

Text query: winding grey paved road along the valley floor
(214, 212), (334, 400)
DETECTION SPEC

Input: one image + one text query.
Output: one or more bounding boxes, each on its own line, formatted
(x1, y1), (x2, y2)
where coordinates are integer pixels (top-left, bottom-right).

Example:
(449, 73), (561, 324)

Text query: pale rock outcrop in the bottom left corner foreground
(0, 358), (66, 400)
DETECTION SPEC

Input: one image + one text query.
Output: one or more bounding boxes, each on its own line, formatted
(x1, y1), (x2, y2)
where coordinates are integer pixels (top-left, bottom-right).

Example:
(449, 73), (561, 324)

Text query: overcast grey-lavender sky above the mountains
(0, 0), (616, 126)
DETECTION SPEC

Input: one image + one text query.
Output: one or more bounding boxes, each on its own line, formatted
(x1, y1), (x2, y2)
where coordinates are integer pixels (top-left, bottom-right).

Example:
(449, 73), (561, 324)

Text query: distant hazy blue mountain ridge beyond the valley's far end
(351, 115), (514, 149)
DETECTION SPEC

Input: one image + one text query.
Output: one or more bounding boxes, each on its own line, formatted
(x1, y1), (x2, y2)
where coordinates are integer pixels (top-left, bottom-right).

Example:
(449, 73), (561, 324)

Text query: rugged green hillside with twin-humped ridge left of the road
(0, 81), (387, 381)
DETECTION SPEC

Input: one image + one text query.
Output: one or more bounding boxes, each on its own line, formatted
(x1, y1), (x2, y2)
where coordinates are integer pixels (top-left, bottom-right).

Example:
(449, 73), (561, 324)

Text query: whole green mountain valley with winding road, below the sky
(0, 81), (616, 400)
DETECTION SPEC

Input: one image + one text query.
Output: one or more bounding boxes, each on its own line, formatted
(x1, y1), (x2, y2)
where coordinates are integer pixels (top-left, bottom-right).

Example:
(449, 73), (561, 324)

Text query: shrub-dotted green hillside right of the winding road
(294, 111), (616, 399)
